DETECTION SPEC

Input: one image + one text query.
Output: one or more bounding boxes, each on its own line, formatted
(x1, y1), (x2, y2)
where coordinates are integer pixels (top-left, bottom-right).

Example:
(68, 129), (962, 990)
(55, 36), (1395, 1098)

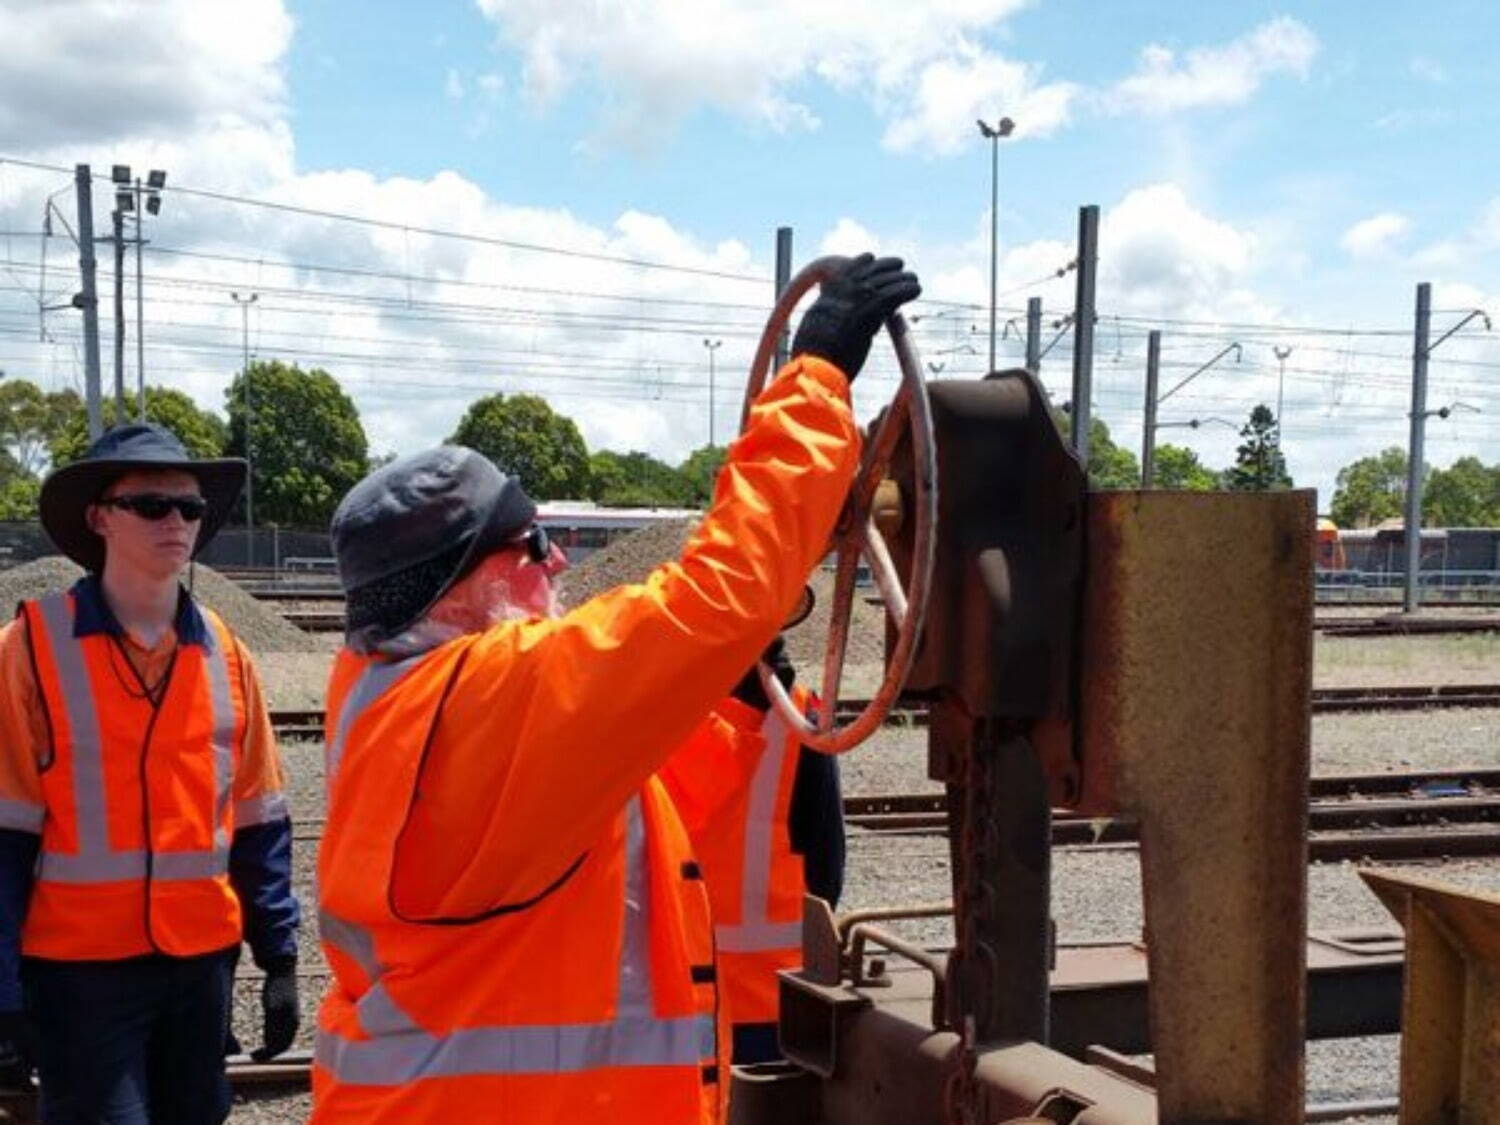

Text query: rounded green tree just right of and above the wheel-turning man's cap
(449, 395), (590, 500)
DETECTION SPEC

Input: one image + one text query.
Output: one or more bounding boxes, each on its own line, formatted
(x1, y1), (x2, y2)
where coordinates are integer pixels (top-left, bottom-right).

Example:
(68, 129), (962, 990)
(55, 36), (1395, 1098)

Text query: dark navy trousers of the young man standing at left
(23, 951), (234, 1125)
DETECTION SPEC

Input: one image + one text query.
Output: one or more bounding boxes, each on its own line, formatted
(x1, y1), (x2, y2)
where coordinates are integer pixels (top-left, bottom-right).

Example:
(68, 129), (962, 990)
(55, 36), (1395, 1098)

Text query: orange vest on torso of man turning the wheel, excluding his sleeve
(314, 648), (728, 1122)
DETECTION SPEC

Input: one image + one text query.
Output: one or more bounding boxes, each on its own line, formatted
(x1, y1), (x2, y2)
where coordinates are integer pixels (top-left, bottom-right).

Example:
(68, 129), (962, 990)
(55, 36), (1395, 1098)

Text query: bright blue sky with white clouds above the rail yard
(0, 0), (1500, 507)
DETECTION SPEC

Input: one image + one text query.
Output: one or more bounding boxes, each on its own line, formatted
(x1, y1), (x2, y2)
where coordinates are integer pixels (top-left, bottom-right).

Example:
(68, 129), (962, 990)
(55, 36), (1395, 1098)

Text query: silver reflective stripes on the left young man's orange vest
(38, 594), (236, 884)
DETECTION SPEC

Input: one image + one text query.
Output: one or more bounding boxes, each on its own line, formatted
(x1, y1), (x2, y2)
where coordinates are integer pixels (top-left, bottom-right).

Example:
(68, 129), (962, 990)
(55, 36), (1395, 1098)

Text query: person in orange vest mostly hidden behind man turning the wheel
(660, 638), (845, 1064)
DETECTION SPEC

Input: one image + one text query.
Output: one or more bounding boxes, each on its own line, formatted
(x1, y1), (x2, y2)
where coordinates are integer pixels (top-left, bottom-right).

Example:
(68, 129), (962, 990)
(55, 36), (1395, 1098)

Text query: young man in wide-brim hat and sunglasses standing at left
(0, 425), (297, 1125)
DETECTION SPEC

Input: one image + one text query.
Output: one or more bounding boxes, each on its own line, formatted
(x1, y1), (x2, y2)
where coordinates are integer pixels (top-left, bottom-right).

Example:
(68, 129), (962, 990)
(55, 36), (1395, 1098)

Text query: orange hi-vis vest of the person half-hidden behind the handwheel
(662, 686), (813, 1025)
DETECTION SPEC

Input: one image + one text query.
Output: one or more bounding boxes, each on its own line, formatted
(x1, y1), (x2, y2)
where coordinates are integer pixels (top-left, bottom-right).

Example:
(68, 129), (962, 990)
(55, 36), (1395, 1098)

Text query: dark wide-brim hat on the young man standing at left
(38, 422), (248, 572)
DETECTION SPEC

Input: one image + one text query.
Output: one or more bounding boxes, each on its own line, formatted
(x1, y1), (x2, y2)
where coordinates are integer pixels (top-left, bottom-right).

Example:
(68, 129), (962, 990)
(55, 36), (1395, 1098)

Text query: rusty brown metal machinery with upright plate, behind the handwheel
(735, 358), (1326, 1125)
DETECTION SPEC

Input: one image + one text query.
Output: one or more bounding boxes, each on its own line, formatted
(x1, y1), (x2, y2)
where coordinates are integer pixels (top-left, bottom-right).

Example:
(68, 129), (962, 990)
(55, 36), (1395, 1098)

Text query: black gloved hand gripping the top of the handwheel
(792, 254), (923, 381)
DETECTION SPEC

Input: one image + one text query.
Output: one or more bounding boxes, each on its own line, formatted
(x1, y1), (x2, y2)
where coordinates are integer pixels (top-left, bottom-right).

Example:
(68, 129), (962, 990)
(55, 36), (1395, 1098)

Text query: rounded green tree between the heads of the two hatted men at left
(224, 360), (369, 527)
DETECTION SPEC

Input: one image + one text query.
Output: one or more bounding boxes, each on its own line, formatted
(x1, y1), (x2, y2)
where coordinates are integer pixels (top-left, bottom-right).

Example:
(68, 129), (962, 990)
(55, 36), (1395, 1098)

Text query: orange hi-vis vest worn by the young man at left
(21, 594), (249, 960)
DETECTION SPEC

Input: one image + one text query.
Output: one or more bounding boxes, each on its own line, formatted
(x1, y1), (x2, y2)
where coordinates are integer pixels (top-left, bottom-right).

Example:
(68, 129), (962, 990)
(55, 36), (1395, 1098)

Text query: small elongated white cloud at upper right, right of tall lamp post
(1104, 17), (1319, 114)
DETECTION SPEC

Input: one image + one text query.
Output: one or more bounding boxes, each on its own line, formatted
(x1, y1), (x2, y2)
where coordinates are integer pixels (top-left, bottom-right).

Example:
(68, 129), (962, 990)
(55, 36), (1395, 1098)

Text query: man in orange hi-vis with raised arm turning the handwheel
(314, 255), (920, 1125)
